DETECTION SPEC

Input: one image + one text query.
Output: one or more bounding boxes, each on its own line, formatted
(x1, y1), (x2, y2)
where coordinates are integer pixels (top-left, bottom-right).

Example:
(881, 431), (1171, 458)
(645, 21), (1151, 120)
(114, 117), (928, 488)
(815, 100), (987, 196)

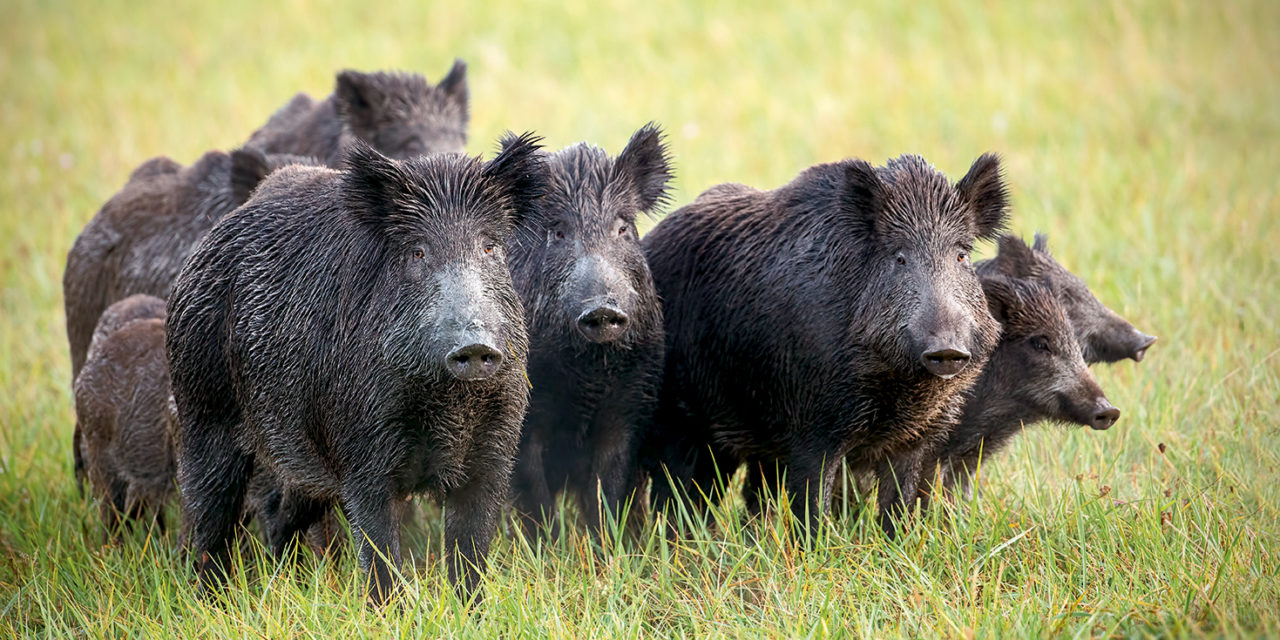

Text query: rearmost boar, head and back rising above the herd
(248, 60), (467, 166)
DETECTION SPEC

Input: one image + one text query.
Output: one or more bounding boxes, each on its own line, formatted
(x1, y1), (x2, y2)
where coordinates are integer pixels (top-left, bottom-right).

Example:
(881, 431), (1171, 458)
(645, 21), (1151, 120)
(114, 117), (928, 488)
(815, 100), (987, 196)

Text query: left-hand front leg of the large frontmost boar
(343, 477), (401, 605)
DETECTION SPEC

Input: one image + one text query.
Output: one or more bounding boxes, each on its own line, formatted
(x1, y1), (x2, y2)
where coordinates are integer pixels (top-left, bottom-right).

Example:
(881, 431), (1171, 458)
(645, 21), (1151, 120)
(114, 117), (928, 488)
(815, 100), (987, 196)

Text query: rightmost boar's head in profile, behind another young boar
(978, 233), (1156, 365)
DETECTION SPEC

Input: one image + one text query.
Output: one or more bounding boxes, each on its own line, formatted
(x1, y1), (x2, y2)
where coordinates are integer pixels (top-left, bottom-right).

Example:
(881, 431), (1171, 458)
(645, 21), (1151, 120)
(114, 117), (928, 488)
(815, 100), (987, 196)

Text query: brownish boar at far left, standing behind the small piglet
(63, 148), (325, 484)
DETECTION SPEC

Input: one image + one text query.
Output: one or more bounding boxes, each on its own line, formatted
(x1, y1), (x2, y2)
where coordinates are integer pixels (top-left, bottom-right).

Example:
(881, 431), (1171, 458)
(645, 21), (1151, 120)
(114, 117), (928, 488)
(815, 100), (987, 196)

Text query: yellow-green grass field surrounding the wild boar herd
(0, 0), (1280, 637)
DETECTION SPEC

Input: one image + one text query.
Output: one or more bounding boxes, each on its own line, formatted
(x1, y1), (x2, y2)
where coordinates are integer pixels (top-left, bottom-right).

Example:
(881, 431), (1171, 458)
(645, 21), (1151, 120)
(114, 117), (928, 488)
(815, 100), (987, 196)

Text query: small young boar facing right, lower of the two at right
(878, 275), (1120, 535)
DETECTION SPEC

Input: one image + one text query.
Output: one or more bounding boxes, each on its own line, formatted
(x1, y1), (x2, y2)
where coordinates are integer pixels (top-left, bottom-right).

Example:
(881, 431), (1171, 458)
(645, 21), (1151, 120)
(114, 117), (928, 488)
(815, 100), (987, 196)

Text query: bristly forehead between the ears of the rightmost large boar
(877, 156), (975, 251)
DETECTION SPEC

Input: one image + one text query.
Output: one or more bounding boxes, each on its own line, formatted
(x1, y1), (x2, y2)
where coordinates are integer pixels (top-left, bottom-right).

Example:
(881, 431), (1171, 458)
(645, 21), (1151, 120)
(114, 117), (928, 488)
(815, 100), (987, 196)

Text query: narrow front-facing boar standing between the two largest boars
(511, 124), (672, 532)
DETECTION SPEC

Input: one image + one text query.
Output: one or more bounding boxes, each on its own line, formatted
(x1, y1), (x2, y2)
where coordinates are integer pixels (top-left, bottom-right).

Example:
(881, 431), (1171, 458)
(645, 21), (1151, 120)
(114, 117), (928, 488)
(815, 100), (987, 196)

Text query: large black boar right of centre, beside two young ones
(641, 155), (1007, 525)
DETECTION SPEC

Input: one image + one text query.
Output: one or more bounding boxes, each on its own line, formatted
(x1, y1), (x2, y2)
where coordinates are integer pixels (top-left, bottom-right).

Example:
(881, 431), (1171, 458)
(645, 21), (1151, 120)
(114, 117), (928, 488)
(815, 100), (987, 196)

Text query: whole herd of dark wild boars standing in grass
(63, 61), (1156, 603)
